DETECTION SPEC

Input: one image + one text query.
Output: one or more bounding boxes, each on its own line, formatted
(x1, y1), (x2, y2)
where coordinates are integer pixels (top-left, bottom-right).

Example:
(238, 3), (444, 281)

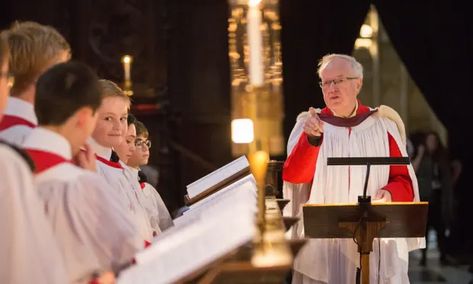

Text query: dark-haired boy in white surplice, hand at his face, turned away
(23, 62), (141, 282)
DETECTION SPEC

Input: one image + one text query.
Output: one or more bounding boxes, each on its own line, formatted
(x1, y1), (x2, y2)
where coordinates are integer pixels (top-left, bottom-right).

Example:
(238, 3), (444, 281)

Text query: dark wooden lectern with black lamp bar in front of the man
(303, 158), (428, 284)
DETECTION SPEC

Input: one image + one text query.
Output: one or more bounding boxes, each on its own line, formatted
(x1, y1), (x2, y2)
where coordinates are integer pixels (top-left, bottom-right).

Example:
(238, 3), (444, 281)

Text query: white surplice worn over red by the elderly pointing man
(284, 110), (424, 283)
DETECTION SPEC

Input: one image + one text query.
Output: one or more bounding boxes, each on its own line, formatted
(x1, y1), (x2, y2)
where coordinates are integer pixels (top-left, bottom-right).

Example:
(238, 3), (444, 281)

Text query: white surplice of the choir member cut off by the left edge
(0, 144), (67, 284)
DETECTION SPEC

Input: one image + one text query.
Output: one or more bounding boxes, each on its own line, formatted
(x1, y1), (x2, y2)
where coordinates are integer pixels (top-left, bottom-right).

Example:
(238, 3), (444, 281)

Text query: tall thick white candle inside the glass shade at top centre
(246, 0), (263, 86)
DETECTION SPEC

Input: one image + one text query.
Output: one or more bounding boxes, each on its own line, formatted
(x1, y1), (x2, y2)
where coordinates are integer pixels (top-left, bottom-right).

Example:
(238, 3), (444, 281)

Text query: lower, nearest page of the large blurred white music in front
(117, 199), (255, 284)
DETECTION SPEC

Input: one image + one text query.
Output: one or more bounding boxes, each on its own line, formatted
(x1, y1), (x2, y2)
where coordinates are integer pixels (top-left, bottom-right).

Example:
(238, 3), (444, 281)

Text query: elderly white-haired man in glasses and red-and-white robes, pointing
(283, 54), (423, 283)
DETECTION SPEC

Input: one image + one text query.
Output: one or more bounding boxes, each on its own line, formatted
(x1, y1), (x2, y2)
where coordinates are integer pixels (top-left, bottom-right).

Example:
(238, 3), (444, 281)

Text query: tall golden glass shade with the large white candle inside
(228, 0), (285, 156)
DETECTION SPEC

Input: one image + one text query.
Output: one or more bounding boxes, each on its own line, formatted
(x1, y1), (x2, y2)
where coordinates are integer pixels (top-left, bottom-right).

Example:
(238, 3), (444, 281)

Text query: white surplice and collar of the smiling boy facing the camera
(89, 139), (153, 246)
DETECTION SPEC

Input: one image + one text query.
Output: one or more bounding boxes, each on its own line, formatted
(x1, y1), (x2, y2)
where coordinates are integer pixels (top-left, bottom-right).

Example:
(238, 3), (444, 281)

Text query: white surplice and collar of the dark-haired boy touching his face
(24, 127), (142, 282)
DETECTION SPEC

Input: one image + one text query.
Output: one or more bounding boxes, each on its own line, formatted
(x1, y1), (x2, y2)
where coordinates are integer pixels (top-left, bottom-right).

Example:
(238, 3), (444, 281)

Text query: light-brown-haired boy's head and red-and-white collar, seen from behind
(0, 22), (71, 145)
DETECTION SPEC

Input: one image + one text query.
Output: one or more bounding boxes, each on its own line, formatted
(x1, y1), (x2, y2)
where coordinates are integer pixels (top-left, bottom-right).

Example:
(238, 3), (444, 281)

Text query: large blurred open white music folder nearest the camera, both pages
(118, 171), (257, 284)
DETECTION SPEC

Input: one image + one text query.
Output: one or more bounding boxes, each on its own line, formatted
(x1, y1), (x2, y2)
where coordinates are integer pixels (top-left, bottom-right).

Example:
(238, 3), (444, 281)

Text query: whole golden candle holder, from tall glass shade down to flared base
(228, 0), (292, 269)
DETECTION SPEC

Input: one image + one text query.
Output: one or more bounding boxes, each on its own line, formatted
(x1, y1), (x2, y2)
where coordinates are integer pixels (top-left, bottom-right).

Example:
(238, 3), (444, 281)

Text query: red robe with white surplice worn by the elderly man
(283, 104), (423, 283)
